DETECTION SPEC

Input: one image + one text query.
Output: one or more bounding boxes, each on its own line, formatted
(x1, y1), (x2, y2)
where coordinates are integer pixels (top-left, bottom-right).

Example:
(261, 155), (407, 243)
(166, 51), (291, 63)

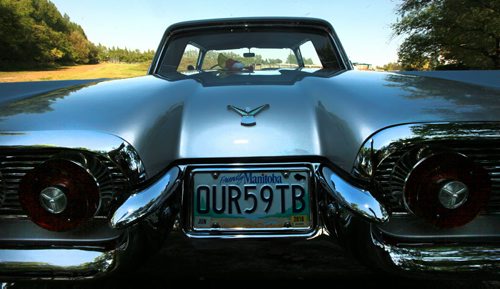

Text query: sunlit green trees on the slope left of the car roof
(0, 0), (154, 69)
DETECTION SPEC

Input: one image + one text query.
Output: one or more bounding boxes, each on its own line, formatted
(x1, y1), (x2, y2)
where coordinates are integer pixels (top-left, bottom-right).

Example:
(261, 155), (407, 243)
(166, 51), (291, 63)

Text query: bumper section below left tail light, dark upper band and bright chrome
(0, 216), (127, 281)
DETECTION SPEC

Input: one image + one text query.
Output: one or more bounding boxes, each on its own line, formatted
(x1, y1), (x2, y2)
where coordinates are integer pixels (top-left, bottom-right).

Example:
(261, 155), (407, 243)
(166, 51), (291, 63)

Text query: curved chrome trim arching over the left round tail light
(0, 130), (147, 183)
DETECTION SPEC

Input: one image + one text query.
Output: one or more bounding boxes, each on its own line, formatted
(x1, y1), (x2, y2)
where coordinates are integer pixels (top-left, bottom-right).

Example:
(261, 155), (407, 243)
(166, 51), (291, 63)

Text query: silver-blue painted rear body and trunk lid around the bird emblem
(0, 71), (500, 177)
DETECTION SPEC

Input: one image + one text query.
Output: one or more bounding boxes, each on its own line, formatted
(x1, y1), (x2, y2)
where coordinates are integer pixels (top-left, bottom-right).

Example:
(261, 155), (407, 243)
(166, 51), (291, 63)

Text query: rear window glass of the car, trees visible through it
(157, 28), (342, 78)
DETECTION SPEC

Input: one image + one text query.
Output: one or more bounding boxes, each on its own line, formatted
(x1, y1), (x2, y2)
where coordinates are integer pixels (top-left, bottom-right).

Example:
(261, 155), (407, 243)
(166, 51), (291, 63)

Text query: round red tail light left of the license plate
(19, 159), (100, 231)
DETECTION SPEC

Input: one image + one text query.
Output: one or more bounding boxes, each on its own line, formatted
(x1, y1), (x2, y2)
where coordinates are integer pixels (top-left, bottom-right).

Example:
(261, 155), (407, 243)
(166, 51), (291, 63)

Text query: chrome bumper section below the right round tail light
(366, 215), (500, 279)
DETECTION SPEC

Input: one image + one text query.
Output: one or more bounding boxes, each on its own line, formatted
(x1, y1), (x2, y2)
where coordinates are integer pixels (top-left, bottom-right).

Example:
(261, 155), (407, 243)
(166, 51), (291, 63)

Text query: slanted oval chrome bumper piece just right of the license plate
(320, 167), (389, 223)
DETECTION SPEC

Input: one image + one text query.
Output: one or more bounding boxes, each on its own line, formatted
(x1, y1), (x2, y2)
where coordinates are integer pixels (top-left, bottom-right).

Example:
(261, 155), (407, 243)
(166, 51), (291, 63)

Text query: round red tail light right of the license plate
(404, 153), (491, 228)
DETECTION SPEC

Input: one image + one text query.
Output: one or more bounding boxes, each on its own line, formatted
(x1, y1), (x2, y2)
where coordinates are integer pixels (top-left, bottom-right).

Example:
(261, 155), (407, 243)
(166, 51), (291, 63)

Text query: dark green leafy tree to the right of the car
(392, 0), (500, 69)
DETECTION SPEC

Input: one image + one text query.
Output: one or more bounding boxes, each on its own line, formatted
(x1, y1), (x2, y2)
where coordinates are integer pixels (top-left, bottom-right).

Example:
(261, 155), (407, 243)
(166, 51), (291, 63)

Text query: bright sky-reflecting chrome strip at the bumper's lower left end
(0, 249), (117, 280)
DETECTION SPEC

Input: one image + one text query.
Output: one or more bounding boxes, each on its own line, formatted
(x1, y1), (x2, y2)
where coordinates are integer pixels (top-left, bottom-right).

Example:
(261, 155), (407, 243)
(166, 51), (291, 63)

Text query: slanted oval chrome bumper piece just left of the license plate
(110, 167), (181, 229)
